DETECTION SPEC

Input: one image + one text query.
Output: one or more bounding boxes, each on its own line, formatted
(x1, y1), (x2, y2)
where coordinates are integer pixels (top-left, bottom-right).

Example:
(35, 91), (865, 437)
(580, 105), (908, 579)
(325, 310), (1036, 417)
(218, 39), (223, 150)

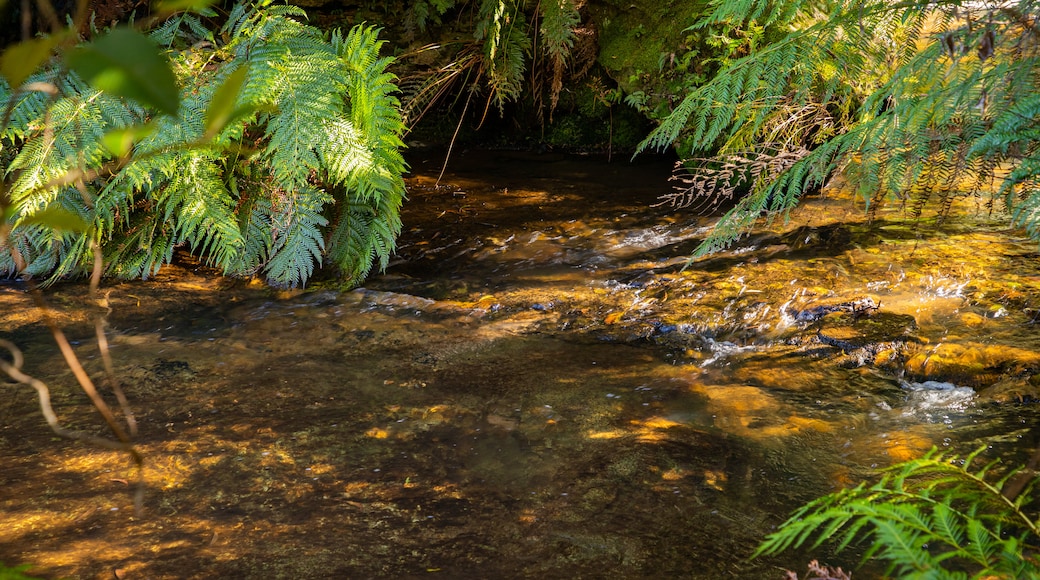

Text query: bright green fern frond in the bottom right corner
(755, 449), (1040, 579)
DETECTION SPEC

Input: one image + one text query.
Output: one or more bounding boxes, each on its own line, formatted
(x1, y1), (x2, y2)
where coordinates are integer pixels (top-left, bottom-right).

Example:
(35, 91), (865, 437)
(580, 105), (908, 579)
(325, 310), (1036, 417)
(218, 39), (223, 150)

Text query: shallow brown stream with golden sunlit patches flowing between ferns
(0, 153), (1040, 578)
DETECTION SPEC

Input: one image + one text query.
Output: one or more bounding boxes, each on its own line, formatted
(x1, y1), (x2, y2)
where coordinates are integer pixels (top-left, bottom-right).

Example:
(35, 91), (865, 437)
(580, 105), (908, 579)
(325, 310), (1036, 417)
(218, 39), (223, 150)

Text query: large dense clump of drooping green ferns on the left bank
(0, 4), (406, 286)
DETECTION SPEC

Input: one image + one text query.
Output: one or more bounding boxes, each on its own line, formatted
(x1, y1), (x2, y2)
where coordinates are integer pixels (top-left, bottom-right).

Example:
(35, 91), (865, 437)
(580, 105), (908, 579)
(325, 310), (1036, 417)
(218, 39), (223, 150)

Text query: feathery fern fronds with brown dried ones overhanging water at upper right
(641, 0), (1040, 254)
